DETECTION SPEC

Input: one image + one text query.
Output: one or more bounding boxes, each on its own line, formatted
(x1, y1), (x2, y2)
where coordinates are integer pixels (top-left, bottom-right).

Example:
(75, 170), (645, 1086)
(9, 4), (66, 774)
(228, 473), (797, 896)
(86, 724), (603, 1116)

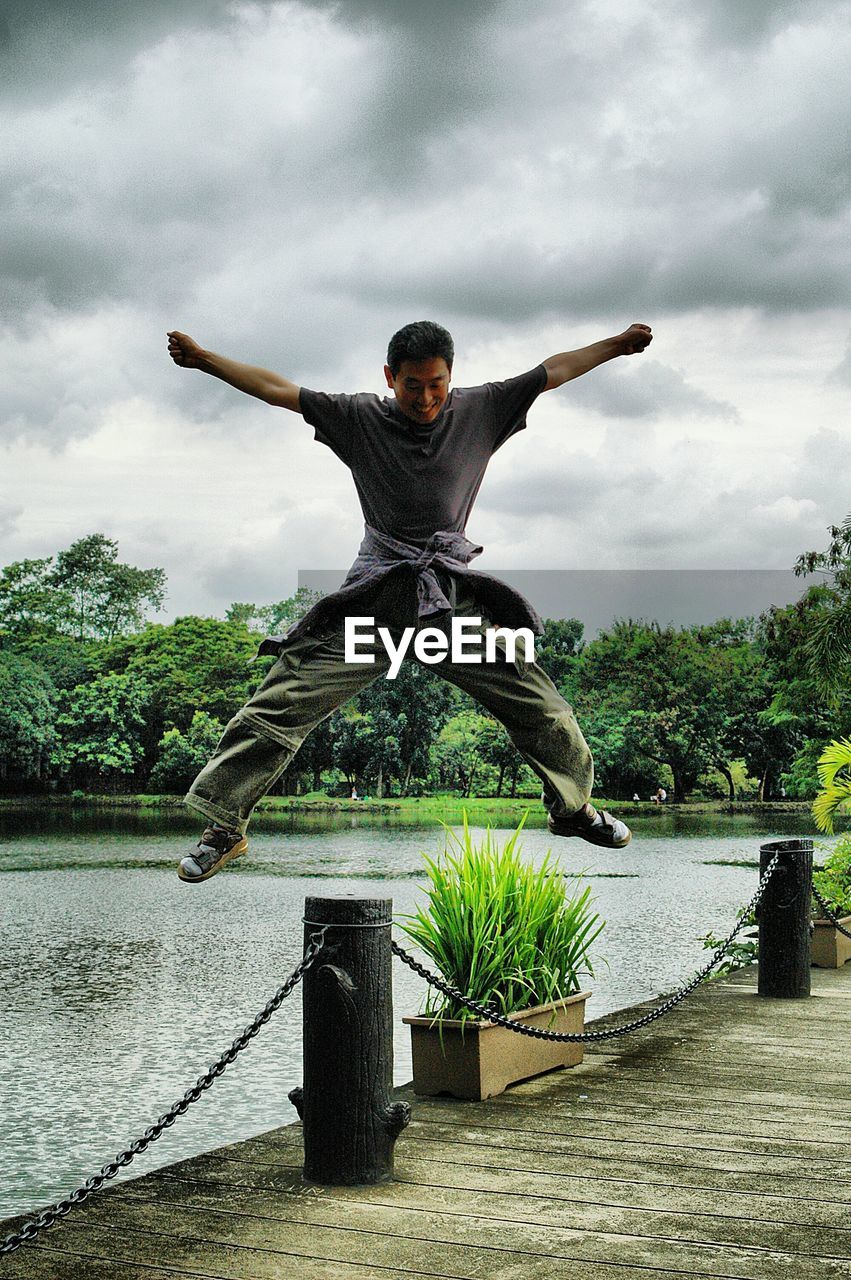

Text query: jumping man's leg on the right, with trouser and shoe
(436, 596), (630, 849)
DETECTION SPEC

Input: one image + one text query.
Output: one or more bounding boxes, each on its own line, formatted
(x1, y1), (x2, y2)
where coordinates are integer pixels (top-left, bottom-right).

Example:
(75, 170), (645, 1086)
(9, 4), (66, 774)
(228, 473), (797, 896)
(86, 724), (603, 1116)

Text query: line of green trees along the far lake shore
(0, 521), (851, 800)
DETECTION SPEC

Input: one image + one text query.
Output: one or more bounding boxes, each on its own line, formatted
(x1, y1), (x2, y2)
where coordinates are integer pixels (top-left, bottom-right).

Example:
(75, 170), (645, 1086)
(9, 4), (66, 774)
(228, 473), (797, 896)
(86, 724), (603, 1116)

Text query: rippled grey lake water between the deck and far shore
(0, 809), (813, 1219)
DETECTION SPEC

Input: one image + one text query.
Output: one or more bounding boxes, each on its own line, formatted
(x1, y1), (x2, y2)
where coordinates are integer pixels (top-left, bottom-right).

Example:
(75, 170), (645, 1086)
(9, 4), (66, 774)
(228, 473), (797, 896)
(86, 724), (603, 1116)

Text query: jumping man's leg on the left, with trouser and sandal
(178, 626), (388, 882)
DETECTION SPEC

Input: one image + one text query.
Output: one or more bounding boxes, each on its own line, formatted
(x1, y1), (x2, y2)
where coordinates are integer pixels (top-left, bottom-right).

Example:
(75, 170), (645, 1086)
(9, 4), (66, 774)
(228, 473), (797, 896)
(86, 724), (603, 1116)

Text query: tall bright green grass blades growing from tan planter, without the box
(399, 814), (605, 1021)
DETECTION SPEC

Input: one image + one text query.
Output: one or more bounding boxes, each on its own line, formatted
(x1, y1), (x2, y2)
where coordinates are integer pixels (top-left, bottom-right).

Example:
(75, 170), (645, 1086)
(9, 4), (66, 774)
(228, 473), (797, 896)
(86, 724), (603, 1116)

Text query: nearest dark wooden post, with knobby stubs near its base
(289, 897), (411, 1187)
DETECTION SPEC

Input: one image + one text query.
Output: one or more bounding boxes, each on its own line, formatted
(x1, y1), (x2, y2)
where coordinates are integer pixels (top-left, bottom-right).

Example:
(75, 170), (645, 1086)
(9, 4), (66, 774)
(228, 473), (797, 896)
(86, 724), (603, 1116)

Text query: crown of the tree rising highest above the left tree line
(49, 534), (165, 640)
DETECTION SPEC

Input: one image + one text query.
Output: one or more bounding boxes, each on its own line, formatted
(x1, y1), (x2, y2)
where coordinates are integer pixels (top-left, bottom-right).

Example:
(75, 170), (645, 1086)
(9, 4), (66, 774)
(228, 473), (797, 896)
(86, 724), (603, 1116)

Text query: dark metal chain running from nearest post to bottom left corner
(0, 929), (325, 1256)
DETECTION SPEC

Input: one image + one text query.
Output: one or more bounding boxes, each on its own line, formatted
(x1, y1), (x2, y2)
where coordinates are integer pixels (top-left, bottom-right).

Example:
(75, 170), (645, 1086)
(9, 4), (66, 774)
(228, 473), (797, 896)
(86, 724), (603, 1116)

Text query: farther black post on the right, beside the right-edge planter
(758, 840), (813, 1000)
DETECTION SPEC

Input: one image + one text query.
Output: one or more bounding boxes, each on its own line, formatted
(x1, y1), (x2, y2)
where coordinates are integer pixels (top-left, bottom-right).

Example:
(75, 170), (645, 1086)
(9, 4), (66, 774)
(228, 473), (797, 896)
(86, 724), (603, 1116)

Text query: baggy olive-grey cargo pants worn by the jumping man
(186, 575), (594, 832)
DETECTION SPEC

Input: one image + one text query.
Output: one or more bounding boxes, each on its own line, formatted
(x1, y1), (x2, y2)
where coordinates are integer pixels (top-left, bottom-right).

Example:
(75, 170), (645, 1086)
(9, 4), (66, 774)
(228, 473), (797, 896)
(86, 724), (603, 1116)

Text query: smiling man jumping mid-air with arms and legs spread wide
(169, 320), (653, 883)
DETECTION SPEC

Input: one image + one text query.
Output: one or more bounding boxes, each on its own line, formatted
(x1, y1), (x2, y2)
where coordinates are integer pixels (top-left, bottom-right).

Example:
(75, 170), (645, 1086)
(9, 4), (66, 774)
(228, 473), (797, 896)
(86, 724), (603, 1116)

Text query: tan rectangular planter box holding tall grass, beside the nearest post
(403, 991), (590, 1102)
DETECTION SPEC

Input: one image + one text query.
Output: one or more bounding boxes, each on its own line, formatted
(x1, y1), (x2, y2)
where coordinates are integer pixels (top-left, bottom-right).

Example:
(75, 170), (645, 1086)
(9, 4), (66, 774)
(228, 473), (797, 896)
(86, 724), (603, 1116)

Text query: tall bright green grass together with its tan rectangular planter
(401, 814), (604, 1100)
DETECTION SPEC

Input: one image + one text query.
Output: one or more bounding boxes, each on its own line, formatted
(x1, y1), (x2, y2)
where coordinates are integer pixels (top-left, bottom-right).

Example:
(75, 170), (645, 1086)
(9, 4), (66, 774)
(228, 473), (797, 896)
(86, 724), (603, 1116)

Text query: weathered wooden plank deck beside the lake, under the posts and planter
(0, 966), (851, 1280)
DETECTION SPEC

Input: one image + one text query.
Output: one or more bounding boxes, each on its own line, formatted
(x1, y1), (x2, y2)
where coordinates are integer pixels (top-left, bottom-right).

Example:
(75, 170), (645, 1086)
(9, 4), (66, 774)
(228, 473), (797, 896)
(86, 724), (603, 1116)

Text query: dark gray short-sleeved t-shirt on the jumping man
(299, 365), (546, 541)
